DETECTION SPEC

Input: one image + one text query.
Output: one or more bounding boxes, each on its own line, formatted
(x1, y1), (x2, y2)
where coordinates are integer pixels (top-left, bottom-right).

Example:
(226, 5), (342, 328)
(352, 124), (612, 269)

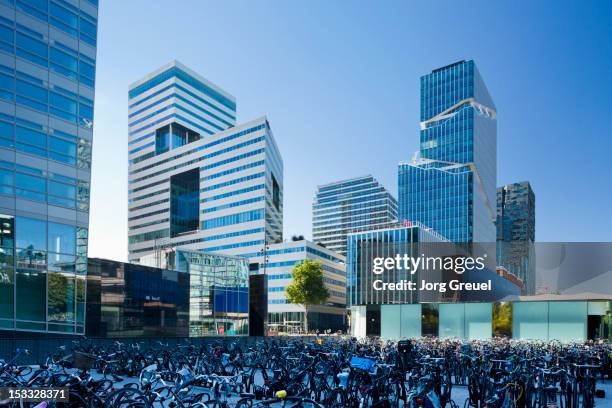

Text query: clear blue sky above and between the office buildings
(89, 0), (612, 260)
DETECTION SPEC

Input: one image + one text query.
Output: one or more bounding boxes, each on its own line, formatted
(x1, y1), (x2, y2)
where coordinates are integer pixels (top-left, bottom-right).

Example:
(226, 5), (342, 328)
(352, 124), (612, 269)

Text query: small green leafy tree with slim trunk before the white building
(285, 259), (329, 332)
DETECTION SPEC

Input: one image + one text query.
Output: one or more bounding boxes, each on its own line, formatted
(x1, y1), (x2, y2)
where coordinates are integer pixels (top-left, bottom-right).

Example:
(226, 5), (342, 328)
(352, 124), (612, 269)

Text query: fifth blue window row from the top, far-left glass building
(0, 161), (89, 211)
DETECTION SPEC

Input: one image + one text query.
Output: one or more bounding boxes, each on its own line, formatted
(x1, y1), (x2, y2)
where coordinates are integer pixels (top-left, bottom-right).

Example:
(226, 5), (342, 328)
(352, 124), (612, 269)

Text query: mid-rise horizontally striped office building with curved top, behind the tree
(312, 176), (397, 255)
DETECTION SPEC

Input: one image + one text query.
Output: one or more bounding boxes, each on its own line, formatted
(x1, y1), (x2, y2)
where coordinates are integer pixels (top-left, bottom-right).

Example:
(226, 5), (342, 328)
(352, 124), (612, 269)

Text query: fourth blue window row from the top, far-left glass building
(0, 113), (91, 169)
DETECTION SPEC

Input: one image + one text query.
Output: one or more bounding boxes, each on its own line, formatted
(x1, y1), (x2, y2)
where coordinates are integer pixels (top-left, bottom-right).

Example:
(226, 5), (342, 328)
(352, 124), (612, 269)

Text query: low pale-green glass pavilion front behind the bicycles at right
(351, 300), (612, 343)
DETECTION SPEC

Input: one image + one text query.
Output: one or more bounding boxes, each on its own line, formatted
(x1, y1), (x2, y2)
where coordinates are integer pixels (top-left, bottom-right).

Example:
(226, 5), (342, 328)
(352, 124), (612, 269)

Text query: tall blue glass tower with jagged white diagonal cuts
(398, 61), (497, 243)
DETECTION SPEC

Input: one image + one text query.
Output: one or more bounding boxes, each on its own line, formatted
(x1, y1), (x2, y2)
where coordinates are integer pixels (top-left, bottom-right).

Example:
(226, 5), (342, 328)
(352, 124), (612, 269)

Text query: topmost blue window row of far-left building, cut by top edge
(8, 0), (97, 47)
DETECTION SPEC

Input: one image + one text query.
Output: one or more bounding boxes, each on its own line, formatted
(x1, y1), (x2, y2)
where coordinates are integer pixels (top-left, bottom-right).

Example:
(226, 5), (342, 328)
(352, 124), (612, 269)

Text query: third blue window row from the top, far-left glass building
(0, 67), (93, 128)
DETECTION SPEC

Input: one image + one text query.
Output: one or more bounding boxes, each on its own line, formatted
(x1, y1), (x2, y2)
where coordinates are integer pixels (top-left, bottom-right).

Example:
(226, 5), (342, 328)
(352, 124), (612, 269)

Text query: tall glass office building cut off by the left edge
(0, 0), (98, 334)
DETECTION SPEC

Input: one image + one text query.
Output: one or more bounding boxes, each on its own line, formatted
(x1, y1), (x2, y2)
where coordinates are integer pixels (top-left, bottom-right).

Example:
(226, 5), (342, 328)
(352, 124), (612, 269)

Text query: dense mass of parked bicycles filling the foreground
(0, 337), (612, 408)
